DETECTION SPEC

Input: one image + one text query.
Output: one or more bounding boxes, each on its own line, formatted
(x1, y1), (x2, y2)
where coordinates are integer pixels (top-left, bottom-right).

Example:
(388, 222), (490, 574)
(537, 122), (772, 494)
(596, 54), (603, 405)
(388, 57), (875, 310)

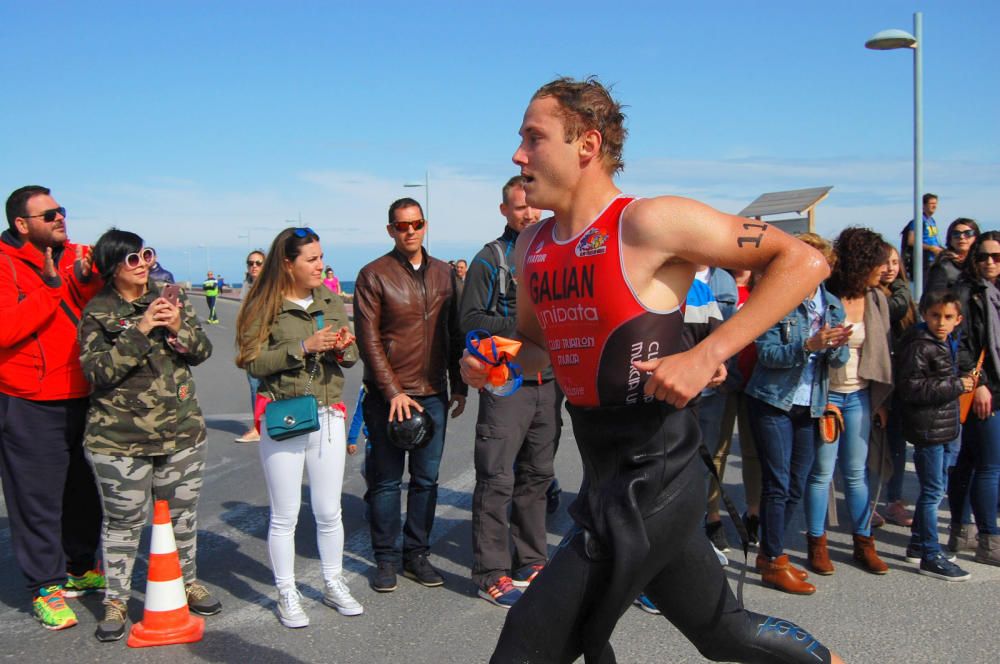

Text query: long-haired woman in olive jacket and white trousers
(236, 228), (363, 627)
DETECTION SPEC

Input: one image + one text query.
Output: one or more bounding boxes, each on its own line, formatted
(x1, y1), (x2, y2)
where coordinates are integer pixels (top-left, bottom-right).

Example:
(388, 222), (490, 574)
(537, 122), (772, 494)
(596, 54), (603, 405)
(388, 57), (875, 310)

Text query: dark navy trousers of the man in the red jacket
(0, 394), (102, 591)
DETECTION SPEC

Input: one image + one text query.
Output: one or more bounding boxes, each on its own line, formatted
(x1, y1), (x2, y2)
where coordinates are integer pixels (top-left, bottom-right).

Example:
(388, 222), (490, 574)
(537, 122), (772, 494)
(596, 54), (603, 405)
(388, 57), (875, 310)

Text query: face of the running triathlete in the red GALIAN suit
(513, 97), (580, 210)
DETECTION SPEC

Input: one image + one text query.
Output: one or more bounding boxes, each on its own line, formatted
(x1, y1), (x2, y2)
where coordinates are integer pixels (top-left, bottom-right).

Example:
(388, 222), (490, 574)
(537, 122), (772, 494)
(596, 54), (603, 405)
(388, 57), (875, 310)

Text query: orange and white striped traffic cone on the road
(128, 500), (205, 648)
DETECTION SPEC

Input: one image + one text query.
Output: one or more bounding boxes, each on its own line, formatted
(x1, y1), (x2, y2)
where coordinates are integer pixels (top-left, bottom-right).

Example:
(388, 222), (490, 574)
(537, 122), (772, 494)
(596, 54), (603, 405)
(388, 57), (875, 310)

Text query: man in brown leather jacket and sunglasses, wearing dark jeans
(354, 198), (468, 592)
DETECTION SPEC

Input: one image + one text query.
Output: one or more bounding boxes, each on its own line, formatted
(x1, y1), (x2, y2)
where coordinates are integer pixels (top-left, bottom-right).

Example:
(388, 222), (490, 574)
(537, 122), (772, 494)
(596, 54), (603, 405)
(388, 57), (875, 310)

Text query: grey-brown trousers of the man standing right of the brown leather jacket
(472, 380), (560, 587)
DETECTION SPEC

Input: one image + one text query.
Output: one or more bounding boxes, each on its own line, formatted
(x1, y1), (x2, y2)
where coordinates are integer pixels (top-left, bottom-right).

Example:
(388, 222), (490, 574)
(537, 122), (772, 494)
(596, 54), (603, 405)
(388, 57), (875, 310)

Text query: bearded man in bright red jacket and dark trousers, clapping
(0, 186), (104, 629)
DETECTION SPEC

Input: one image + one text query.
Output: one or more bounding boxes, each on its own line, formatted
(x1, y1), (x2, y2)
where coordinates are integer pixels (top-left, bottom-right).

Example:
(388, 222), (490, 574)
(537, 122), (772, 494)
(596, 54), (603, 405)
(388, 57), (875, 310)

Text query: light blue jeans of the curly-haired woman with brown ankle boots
(805, 389), (872, 537)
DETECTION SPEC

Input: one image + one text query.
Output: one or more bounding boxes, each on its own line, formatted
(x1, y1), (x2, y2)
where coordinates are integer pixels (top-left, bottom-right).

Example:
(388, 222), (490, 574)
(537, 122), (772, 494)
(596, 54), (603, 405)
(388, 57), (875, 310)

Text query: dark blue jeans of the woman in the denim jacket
(748, 397), (816, 558)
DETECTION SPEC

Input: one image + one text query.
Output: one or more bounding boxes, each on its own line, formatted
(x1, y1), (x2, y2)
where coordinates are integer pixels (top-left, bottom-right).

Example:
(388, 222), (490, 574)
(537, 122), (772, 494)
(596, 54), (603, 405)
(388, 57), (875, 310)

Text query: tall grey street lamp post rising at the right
(865, 12), (924, 301)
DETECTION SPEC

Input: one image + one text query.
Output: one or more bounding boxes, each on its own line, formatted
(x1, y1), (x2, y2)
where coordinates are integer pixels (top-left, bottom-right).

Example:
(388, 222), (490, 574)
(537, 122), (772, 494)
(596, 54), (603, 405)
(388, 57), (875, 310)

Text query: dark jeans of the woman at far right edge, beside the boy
(956, 411), (1000, 535)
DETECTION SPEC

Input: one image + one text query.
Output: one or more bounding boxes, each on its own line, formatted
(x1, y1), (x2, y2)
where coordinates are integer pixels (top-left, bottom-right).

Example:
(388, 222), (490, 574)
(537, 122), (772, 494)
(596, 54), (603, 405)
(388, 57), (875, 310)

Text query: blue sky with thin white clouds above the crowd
(0, 0), (1000, 281)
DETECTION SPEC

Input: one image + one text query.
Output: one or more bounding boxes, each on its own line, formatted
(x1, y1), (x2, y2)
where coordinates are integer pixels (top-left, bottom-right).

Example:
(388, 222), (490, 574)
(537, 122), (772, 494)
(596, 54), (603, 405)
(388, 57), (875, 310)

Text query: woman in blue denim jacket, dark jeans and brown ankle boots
(746, 233), (850, 595)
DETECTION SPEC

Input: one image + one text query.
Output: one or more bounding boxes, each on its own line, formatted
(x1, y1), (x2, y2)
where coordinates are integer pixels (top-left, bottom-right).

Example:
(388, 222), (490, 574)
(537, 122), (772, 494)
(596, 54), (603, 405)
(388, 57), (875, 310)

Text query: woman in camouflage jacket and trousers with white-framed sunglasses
(80, 228), (222, 641)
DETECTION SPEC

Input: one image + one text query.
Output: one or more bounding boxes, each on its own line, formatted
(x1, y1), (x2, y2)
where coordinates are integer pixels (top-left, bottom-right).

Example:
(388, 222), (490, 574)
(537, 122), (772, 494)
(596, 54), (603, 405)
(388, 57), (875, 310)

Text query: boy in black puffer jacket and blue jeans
(896, 291), (973, 581)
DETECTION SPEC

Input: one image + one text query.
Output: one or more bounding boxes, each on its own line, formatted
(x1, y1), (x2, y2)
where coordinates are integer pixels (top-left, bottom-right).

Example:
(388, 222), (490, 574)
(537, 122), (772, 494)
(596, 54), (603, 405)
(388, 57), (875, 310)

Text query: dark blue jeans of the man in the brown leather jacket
(362, 390), (448, 565)
